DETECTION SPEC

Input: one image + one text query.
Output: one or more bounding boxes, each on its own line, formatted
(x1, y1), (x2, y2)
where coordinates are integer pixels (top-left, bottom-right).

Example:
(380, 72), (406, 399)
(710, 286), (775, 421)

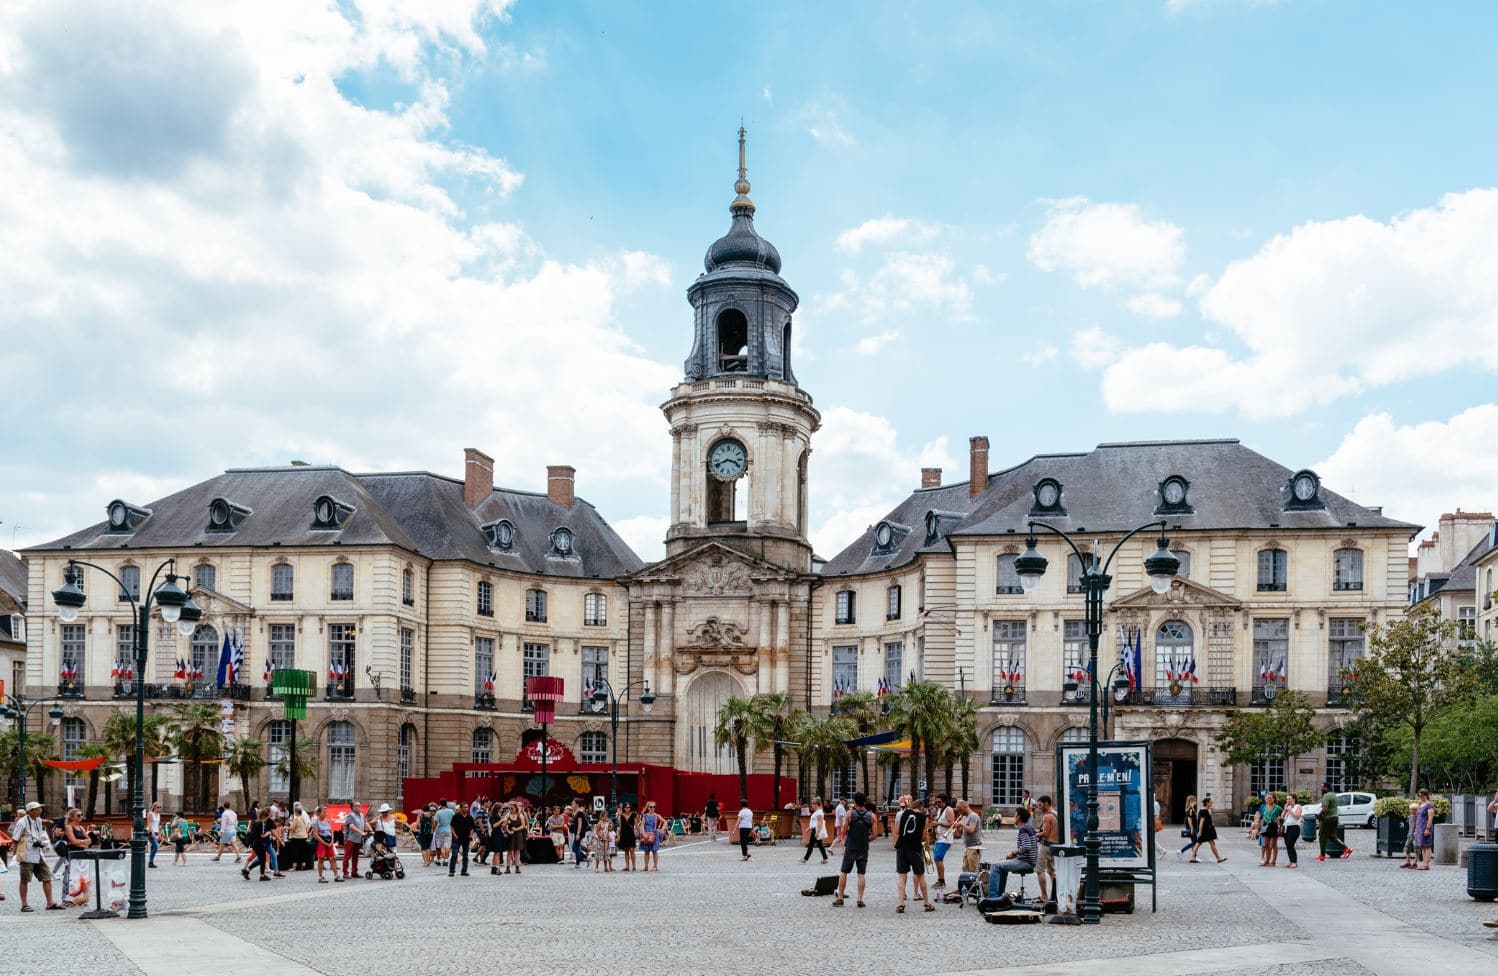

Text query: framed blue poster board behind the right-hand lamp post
(1056, 741), (1155, 870)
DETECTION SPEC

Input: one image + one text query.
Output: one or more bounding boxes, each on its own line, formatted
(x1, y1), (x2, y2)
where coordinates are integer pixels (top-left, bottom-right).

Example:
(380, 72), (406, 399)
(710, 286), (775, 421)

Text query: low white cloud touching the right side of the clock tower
(809, 407), (956, 558)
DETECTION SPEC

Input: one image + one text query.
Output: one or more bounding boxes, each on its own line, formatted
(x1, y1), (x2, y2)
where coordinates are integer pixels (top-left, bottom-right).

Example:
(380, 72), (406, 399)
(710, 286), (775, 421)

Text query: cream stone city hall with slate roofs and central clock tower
(25, 135), (1419, 814)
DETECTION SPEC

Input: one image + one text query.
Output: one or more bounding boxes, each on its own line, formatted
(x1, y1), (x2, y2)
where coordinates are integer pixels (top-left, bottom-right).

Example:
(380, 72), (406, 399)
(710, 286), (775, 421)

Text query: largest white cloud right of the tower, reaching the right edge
(1104, 189), (1498, 418)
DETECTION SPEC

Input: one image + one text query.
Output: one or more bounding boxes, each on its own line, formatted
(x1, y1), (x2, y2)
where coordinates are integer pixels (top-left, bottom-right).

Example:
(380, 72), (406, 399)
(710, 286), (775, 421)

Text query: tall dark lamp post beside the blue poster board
(1014, 519), (1180, 925)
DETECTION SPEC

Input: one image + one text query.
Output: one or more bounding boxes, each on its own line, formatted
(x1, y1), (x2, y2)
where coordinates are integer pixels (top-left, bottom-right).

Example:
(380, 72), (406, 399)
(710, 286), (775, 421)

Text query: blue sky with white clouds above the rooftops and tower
(0, 0), (1498, 558)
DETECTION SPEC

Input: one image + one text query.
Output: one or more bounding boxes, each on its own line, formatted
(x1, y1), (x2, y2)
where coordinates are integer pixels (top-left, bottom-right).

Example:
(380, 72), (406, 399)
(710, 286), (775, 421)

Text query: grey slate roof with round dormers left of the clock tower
(24, 466), (643, 578)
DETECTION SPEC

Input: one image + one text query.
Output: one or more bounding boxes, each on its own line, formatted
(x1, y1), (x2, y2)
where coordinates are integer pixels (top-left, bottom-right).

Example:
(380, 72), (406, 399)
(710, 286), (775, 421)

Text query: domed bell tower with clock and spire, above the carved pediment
(661, 127), (821, 573)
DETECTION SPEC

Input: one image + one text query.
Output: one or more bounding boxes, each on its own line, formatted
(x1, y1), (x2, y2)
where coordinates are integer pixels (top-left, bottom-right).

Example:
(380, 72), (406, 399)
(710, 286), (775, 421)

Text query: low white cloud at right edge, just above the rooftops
(1315, 403), (1498, 527)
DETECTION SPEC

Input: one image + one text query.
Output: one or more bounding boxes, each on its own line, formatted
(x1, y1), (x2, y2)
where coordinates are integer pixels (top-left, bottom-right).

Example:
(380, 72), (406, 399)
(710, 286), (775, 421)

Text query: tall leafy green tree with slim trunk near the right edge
(1344, 606), (1483, 796)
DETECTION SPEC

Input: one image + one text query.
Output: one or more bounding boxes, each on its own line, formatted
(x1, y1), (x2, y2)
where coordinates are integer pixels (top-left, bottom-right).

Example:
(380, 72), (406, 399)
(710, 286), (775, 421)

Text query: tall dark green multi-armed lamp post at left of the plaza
(52, 560), (202, 919)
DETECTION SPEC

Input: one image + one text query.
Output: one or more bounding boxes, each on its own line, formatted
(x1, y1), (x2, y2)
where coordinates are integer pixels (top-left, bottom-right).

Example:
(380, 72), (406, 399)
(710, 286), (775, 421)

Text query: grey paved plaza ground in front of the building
(0, 831), (1498, 976)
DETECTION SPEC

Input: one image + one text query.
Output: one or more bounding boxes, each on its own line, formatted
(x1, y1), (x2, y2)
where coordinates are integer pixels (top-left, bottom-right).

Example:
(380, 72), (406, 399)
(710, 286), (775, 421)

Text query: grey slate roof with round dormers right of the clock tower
(824, 440), (1420, 575)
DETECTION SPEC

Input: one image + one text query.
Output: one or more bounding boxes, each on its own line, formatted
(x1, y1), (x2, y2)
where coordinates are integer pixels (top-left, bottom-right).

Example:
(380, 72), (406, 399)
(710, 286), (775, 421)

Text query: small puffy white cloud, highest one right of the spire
(1026, 196), (1186, 287)
